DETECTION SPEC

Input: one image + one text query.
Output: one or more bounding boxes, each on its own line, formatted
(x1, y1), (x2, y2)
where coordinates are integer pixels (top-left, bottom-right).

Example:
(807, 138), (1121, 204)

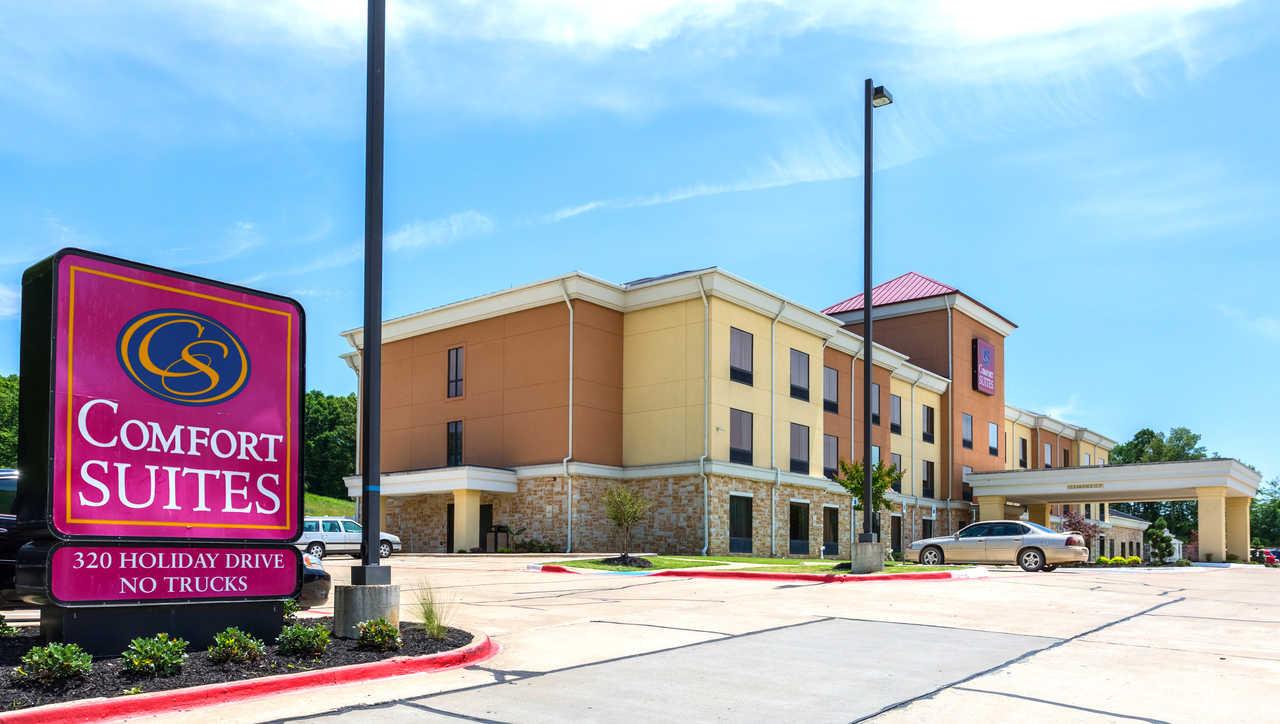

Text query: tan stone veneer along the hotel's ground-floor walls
(383, 475), (972, 559)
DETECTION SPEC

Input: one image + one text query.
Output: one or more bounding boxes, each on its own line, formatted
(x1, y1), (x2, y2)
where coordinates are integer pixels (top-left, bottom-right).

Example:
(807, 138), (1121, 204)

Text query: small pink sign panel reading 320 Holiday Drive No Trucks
(49, 544), (301, 605)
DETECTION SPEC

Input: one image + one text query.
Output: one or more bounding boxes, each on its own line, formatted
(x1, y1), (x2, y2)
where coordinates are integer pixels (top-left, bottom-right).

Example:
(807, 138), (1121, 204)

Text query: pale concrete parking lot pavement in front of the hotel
(124, 555), (1280, 721)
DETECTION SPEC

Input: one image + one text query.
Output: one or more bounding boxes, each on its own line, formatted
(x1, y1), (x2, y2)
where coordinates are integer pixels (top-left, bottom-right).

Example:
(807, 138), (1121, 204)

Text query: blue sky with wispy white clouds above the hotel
(0, 0), (1280, 477)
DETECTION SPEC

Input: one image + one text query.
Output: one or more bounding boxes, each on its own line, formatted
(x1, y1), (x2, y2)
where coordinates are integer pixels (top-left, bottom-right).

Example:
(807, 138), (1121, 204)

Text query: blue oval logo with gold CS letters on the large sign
(115, 310), (248, 405)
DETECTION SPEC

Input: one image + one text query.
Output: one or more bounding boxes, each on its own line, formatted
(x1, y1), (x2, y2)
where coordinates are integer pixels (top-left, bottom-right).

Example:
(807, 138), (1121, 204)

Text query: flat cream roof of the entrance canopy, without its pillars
(964, 459), (1261, 505)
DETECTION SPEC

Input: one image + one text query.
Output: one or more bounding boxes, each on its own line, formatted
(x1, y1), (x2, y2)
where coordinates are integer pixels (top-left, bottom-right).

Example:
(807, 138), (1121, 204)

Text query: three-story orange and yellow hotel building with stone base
(344, 267), (1140, 558)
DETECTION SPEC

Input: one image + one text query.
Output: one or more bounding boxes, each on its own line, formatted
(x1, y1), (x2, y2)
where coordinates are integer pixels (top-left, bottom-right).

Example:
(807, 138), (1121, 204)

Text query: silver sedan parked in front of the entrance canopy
(906, 521), (1089, 571)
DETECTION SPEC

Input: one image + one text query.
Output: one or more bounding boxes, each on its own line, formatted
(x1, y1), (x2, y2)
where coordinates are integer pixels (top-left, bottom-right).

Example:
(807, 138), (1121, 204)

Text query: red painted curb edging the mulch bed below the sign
(0, 633), (499, 724)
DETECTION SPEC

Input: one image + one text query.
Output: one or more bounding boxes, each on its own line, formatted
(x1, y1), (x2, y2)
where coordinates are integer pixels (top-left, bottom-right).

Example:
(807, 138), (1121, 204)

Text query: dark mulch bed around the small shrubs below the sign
(0, 618), (471, 711)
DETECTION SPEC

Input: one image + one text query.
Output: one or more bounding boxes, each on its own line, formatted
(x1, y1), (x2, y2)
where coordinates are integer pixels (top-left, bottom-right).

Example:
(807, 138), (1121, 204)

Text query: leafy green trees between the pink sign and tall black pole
(303, 390), (356, 498)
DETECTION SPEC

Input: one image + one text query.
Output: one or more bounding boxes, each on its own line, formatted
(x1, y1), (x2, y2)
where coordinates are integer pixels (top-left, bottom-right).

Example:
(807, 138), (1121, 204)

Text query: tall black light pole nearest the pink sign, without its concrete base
(351, 0), (390, 585)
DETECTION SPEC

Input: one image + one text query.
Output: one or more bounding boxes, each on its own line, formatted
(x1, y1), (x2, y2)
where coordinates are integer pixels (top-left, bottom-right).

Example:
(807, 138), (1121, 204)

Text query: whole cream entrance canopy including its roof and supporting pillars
(964, 459), (1261, 563)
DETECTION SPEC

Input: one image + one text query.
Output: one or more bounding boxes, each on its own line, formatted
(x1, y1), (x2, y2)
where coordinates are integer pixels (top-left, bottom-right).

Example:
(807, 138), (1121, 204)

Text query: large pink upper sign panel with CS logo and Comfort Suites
(49, 253), (303, 541)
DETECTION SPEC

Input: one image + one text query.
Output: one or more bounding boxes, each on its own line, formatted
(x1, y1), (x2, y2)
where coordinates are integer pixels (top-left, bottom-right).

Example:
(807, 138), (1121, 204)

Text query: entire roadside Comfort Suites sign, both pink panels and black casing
(17, 249), (303, 604)
